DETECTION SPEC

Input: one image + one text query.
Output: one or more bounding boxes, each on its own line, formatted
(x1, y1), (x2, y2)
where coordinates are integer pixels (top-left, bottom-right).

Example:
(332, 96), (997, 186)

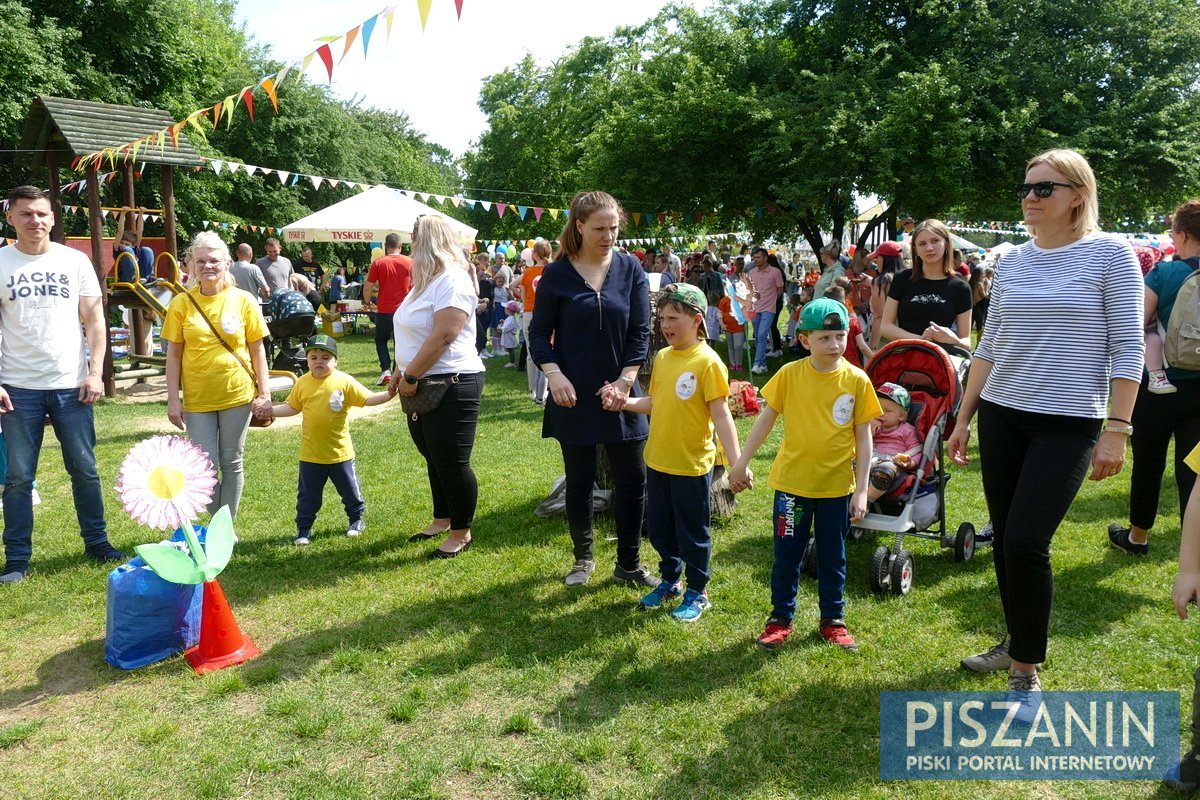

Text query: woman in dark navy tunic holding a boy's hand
(529, 192), (659, 589)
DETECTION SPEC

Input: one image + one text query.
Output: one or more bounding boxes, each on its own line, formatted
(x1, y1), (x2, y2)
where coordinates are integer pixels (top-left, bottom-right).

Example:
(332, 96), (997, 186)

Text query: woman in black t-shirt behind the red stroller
(880, 219), (971, 350)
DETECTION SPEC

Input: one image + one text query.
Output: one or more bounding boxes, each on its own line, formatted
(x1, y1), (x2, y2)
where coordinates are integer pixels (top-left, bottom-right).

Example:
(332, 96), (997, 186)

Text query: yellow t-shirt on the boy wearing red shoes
(762, 359), (883, 498)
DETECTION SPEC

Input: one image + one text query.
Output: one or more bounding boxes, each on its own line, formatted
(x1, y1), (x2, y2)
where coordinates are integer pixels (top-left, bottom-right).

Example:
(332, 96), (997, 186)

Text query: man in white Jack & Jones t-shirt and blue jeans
(0, 186), (126, 583)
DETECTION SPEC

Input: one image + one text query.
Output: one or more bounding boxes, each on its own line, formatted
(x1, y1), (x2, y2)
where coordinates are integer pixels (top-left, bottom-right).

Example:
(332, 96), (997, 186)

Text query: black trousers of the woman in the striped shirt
(979, 401), (1102, 663)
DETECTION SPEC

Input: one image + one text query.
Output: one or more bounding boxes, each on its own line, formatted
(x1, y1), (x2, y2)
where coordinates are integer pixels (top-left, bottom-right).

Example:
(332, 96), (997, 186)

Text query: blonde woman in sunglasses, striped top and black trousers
(948, 150), (1144, 692)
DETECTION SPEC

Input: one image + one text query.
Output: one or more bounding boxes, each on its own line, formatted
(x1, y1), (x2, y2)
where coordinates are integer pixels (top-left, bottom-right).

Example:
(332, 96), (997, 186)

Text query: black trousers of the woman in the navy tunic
(559, 439), (646, 570)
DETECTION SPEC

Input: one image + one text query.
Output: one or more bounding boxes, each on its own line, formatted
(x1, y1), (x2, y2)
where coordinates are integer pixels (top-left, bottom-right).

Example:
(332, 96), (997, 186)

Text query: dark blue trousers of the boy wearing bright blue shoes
(646, 468), (713, 591)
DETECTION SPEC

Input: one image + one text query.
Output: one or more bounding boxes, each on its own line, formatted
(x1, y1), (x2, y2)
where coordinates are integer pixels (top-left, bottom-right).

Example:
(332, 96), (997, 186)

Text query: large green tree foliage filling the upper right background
(467, 0), (1200, 247)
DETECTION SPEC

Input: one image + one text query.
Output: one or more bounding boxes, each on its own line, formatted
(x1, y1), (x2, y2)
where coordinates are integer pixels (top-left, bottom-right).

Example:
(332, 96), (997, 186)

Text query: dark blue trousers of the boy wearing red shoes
(770, 491), (850, 620)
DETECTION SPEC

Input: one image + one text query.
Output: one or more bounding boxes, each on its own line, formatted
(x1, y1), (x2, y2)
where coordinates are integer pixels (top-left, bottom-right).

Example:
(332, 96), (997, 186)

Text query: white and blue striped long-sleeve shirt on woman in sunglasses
(976, 233), (1145, 419)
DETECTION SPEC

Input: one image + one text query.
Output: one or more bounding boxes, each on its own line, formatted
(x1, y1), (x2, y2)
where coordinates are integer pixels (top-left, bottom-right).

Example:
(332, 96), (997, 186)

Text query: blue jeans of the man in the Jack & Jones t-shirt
(4, 386), (108, 566)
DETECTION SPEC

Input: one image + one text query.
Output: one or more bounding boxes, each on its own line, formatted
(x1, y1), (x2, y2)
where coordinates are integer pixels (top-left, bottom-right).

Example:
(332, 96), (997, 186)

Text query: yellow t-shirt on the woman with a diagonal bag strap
(162, 287), (266, 411)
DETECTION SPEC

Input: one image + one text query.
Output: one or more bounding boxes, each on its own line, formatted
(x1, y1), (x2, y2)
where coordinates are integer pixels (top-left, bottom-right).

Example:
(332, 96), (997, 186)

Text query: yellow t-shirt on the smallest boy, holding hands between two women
(288, 369), (371, 464)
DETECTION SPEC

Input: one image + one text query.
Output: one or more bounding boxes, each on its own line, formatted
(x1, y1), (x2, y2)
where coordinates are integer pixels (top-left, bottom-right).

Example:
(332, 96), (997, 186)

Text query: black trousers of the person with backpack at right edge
(1129, 377), (1200, 530)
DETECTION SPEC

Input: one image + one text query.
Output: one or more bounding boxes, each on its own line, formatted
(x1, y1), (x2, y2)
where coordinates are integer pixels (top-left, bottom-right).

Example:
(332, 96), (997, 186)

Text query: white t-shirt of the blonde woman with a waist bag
(392, 264), (484, 375)
